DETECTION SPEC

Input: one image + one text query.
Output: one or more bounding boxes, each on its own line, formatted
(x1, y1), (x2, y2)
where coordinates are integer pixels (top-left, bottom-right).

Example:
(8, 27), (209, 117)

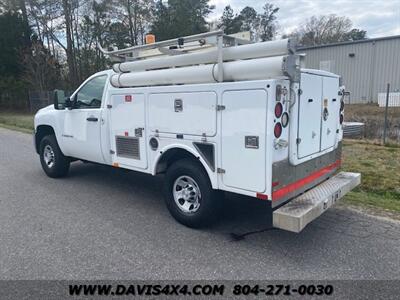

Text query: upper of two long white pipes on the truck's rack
(113, 39), (293, 73)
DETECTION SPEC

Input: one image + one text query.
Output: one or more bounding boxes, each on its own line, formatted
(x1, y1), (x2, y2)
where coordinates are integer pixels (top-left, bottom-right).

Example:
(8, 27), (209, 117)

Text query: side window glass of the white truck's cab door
(75, 75), (107, 108)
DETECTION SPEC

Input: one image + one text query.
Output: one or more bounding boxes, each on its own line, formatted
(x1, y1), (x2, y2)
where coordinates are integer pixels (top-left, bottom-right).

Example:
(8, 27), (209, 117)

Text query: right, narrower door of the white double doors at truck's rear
(321, 77), (340, 151)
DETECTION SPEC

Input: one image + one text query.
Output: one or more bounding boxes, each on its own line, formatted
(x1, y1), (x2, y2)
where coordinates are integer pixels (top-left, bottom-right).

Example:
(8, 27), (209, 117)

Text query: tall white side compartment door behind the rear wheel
(221, 89), (267, 192)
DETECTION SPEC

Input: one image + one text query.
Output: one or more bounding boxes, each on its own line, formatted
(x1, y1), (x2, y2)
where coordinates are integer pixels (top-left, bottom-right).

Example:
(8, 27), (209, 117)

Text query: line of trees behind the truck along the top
(0, 0), (366, 110)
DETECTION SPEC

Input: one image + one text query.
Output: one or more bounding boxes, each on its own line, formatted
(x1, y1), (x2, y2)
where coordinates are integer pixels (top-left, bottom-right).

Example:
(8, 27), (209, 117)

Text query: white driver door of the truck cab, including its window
(62, 75), (108, 163)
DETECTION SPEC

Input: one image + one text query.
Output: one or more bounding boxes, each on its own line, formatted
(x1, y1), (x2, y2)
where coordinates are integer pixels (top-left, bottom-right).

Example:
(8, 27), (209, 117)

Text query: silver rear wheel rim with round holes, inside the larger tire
(173, 176), (201, 213)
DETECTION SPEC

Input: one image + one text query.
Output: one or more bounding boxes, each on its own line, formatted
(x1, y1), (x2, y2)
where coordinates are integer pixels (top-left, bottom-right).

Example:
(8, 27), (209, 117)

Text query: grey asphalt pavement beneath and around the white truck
(0, 128), (400, 280)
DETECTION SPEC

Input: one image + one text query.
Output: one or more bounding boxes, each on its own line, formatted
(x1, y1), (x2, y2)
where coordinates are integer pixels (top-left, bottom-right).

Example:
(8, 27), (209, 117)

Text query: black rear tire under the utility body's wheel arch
(164, 159), (223, 228)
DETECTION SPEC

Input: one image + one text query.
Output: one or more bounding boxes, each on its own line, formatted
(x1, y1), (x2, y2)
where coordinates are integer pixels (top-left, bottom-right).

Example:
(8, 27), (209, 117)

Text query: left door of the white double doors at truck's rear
(297, 73), (324, 158)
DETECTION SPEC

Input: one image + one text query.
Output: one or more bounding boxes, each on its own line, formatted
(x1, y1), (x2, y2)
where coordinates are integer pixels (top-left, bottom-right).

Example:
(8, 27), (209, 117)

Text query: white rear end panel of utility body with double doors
(289, 69), (343, 165)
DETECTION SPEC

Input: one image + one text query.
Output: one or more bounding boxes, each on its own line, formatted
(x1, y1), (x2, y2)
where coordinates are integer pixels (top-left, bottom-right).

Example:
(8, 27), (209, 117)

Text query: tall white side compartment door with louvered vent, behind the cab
(109, 93), (147, 169)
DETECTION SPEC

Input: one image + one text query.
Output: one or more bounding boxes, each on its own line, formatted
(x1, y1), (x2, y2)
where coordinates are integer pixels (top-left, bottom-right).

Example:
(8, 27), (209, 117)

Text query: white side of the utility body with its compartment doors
(103, 80), (282, 196)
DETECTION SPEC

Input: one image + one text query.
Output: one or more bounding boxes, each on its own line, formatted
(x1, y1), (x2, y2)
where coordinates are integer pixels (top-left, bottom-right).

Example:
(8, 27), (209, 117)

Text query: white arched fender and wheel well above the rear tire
(153, 145), (217, 188)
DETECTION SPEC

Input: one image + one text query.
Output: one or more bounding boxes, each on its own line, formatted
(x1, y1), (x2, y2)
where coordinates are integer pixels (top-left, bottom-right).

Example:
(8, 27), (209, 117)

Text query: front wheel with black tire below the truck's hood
(39, 135), (70, 178)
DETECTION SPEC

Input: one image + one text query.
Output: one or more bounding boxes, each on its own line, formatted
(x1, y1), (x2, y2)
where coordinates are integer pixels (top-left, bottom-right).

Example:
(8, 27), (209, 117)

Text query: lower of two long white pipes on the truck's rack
(111, 55), (286, 87)
